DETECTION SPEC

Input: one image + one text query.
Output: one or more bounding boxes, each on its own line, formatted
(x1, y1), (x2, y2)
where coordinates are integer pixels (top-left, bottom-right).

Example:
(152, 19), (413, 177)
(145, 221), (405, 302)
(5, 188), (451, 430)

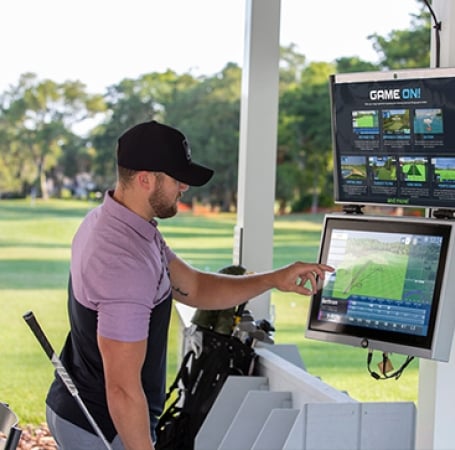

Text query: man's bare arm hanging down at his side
(98, 335), (154, 450)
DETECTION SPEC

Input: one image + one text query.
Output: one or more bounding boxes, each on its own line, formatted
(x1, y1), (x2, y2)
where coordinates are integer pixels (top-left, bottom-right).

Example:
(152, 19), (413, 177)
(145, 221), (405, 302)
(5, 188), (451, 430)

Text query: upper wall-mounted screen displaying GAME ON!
(330, 68), (455, 209)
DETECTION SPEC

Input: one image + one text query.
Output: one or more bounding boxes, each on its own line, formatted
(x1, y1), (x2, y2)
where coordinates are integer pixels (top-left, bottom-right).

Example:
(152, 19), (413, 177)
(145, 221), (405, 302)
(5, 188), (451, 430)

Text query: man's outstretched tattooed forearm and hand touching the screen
(169, 253), (333, 309)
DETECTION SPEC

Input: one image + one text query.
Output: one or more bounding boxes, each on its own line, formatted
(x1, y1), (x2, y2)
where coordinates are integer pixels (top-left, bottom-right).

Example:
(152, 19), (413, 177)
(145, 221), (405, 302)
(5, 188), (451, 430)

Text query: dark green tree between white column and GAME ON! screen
(276, 63), (335, 211)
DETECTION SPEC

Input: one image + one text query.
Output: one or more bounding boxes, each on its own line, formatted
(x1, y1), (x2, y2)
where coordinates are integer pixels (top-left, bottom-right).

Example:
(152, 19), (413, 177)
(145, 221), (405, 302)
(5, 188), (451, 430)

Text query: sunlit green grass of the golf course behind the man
(0, 200), (418, 424)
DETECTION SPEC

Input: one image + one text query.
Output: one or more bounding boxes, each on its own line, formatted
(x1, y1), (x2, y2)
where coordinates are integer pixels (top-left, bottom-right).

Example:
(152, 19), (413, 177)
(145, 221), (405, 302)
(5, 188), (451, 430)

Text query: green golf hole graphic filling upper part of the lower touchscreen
(323, 231), (439, 303)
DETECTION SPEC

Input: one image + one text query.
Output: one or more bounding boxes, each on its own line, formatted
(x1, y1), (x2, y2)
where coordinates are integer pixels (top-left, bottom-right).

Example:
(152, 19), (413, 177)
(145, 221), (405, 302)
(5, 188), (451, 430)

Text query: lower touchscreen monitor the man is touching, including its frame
(306, 213), (455, 361)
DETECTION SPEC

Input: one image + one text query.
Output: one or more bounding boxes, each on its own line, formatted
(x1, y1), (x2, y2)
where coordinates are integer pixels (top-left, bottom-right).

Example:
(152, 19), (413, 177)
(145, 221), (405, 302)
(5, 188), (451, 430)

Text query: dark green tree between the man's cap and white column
(166, 63), (241, 211)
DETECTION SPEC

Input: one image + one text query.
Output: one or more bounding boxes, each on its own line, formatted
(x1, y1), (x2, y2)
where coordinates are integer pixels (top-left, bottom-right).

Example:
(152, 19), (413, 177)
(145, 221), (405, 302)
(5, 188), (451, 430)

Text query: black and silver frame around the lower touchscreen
(305, 214), (454, 360)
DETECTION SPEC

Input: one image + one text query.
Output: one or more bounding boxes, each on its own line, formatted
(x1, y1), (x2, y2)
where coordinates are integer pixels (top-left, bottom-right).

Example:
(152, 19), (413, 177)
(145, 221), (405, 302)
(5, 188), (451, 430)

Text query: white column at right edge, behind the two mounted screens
(416, 0), (455, 450)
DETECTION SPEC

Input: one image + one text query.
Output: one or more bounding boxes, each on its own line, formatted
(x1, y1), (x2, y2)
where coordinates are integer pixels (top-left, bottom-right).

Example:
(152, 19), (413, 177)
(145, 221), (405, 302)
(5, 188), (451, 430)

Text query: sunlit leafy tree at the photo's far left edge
(0, 73), (104, 198)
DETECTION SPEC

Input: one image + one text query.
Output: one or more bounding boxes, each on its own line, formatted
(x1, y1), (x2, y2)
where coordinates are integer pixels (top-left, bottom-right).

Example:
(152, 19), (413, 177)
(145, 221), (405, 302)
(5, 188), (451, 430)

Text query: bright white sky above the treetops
(0, 0), (420, 93)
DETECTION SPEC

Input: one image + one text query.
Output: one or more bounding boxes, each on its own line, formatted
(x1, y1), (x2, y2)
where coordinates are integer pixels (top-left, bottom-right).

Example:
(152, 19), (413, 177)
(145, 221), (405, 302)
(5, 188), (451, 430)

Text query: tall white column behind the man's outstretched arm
(234, 0), (280, 319)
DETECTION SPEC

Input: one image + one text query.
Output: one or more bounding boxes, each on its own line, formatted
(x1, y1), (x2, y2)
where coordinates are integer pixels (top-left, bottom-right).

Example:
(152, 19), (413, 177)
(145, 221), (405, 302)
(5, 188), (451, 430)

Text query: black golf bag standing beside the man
(156, 325), (256, 450)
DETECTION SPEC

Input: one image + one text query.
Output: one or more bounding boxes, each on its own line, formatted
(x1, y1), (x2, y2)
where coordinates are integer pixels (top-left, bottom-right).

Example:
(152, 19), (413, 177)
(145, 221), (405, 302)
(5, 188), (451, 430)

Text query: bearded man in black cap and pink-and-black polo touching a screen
(46, 121), (332, 450)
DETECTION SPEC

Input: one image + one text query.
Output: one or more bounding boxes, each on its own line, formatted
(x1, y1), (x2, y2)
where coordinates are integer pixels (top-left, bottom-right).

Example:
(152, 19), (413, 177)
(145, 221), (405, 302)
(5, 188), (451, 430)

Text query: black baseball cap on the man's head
(117, 120), (213, 186)
